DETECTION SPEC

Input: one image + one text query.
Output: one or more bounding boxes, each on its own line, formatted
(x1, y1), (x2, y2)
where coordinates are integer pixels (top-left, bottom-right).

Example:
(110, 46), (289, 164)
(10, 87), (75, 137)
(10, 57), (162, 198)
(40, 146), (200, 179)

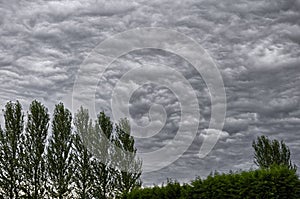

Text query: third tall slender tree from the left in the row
(47, 103), (74, 199)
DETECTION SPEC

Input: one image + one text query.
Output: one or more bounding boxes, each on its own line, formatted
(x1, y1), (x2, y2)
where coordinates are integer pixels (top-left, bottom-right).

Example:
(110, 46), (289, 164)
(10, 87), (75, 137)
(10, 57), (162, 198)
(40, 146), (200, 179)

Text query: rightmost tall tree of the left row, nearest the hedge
(115, 118), (142, 196)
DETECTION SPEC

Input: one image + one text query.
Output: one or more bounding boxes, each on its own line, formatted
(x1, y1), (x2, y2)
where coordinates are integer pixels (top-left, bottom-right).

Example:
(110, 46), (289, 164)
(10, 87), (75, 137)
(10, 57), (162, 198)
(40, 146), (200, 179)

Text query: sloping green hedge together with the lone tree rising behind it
(122, 136), (300, 199)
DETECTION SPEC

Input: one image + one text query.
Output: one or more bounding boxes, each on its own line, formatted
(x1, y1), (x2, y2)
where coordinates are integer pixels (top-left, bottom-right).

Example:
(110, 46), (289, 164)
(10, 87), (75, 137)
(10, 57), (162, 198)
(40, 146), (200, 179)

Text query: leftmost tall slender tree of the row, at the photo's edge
(0, 101), (24, 199)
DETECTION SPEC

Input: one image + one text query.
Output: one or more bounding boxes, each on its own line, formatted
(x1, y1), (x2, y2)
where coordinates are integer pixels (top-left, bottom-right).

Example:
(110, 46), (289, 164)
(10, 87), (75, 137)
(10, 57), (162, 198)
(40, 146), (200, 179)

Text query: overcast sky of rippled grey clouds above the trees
(0, 0), (300, 185)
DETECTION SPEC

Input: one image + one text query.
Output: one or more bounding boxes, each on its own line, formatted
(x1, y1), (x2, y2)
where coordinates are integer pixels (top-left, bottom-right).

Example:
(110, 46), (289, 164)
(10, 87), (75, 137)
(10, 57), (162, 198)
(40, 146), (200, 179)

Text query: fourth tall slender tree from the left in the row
(74, 107), (94, 199)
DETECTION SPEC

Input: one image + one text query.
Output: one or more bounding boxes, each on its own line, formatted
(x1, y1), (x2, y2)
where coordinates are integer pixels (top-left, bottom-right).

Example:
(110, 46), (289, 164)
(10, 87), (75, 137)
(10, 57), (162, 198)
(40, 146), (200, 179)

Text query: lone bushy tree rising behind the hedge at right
(252, 135), (297, 170)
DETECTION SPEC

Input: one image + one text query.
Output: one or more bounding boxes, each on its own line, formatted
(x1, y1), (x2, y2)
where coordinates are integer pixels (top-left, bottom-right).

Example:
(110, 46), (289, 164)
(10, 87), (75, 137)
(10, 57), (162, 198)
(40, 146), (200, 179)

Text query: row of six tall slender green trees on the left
(0, 101), (142, 199)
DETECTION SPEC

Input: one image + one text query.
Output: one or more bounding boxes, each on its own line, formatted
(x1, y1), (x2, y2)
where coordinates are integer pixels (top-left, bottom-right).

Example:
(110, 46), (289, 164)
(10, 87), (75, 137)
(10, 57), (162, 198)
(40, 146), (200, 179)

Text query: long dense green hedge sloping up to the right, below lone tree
(123, 166), (300, 199)
